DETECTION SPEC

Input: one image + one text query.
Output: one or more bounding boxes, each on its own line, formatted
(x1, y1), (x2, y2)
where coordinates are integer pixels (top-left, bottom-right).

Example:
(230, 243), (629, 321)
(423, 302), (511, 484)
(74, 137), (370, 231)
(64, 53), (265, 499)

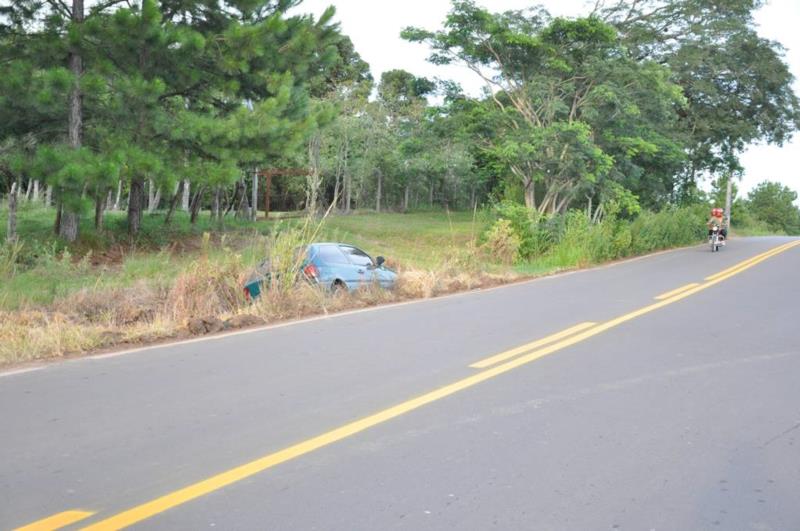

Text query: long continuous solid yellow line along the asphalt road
(83, 241), (800, 531)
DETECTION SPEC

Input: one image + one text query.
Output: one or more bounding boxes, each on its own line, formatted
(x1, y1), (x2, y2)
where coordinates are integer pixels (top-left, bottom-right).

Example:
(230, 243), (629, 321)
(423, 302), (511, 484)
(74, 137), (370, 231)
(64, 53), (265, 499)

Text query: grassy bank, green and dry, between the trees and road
(0, 207), (708, 365)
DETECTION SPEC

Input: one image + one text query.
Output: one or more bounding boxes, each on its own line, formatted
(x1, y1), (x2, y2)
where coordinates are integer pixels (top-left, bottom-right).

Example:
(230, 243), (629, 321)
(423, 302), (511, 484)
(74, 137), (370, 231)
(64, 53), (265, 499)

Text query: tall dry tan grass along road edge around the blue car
(0, 207), (514, 365)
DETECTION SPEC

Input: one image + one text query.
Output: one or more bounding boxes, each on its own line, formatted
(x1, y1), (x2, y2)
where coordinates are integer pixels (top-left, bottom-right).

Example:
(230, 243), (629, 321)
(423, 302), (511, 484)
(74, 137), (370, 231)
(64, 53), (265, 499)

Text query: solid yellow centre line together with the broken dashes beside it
(20, 240), (800, 531)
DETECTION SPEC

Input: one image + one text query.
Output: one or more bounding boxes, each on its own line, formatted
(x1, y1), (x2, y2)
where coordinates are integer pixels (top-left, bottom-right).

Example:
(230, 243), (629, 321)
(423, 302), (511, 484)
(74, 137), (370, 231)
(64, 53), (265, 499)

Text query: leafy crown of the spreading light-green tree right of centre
(403, 1), (685, 213)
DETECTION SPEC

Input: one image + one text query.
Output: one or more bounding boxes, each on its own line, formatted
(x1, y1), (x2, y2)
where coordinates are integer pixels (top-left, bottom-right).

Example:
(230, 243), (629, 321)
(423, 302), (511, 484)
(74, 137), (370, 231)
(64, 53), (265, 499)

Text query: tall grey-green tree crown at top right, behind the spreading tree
(601, 0), (800, 180)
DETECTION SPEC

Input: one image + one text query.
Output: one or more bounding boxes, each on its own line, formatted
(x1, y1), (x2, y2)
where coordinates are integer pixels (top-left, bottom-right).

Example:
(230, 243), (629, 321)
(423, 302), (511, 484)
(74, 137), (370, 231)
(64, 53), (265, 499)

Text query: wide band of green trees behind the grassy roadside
(0, 0), (800, 240)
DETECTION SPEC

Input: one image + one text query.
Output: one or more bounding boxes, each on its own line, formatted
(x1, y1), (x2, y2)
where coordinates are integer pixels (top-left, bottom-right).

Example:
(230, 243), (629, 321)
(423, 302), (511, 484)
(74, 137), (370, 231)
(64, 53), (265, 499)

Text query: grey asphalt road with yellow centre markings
(0, 238), (800, 531)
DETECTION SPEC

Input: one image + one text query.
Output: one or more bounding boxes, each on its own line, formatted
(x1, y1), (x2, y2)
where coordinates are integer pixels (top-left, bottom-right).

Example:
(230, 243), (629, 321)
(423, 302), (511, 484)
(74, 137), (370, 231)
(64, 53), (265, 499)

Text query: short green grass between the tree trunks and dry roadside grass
(0, 205), (488, 310)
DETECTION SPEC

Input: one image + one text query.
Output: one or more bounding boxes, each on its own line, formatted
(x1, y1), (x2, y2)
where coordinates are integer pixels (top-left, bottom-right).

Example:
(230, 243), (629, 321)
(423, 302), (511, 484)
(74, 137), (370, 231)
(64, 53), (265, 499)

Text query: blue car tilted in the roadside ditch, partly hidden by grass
(244, 243), (397, 298)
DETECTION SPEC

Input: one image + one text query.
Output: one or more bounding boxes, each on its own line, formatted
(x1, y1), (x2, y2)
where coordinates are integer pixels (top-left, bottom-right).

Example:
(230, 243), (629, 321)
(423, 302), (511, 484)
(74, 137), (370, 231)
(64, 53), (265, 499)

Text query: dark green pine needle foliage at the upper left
(0, 0), (370, 237)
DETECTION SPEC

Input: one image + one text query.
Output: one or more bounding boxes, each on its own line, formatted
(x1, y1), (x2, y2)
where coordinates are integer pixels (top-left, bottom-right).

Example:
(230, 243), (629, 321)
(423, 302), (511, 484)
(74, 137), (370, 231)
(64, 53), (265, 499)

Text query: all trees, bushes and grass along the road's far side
(0, 0), (800, 363)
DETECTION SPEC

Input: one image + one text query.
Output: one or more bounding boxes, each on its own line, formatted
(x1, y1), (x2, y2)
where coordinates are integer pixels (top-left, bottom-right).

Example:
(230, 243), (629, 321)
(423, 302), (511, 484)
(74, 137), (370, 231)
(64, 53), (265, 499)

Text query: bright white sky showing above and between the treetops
(297, 0), (800, 204)
